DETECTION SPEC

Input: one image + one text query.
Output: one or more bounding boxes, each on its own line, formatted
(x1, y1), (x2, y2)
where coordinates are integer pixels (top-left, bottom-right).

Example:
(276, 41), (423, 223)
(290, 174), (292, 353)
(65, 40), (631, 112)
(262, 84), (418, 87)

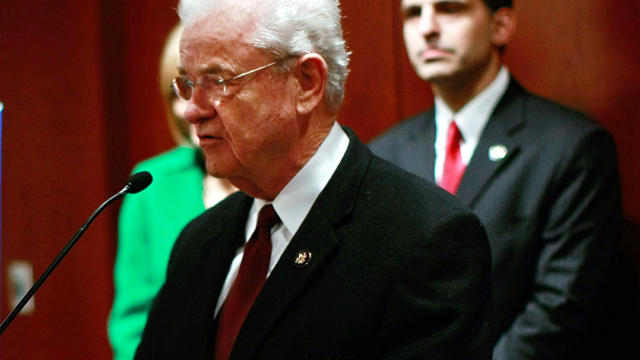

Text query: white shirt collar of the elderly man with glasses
(246, 122), (349, 239)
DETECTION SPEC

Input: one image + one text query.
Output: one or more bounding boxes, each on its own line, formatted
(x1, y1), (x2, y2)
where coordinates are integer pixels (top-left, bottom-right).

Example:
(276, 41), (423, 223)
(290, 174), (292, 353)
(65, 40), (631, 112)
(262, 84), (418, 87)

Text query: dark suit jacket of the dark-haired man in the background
(370, 79), (632, 359)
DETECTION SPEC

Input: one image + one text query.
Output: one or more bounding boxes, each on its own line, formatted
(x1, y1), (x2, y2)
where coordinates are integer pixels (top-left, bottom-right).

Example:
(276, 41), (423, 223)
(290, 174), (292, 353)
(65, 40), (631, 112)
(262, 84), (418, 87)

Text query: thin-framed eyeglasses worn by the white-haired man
(171, 59), (284, 101)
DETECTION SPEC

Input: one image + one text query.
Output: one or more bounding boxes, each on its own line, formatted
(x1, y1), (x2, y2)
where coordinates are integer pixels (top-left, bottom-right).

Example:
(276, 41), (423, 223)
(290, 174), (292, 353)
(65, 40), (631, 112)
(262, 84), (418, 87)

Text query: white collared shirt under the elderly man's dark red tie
(214, 122), (349, 316)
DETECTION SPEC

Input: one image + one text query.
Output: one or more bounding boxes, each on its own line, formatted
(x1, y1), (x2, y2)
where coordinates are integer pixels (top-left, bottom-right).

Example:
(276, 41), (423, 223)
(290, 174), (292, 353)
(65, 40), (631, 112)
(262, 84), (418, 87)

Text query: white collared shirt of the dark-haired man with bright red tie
(434, 66), (509, 182)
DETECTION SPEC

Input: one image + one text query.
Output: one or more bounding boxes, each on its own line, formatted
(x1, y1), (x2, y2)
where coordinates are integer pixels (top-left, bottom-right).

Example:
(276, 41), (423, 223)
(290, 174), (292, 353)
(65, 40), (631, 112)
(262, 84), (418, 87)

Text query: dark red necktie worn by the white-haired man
(215, 204), (279, 360)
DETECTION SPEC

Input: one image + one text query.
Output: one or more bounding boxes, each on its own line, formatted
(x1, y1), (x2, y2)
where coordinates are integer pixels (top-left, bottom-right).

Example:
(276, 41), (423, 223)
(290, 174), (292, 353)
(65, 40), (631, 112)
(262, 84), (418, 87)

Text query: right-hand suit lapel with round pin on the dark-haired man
(456, 79), (525, 208)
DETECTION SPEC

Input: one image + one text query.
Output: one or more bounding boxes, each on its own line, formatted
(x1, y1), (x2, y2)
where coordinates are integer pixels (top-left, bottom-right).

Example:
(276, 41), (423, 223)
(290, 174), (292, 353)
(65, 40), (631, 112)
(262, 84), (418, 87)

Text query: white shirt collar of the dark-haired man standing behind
(435, 66), (509, 147)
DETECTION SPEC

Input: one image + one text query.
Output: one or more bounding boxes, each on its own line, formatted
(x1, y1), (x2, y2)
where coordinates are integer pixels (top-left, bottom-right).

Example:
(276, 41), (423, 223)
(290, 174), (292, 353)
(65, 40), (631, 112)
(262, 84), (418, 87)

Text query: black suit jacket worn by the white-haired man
(136, 130), (490, 360)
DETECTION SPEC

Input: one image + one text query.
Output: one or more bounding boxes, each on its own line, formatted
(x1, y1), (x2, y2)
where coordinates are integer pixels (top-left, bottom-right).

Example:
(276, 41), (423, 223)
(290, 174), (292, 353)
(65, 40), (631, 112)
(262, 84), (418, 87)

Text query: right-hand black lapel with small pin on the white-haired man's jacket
(230, 129), (371, 360)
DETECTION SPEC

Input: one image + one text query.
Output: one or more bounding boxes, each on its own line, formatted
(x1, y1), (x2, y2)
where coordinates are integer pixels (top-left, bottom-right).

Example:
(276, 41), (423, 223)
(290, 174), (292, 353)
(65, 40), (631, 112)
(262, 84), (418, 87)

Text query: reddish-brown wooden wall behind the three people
(0, 0), (640, 360)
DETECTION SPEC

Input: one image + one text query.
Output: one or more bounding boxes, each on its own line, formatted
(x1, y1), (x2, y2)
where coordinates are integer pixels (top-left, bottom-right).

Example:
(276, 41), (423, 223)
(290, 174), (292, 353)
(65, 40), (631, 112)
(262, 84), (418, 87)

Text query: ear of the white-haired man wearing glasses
(295, 53), (328, 115)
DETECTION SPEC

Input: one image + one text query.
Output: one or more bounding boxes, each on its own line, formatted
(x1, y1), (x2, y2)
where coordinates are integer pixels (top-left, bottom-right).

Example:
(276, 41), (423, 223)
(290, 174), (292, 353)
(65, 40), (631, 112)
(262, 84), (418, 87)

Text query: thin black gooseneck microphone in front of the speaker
(0, 171), (153, 335)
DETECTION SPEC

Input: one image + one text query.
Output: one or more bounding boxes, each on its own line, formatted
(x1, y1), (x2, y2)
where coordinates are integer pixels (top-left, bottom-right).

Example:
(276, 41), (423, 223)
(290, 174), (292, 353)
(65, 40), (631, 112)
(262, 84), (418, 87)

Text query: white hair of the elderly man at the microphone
(178, 0), (350, 111)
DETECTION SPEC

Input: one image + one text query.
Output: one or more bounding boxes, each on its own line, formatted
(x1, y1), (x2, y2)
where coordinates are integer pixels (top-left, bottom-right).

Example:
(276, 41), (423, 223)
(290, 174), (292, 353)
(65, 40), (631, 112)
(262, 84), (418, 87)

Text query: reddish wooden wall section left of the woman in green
(0, 1), (114, 359)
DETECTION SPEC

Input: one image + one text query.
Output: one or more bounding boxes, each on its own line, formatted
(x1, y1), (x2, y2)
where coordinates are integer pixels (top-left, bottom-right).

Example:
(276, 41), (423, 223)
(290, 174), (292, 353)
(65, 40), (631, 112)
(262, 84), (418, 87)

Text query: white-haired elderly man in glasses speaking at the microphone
(136, 0), (490, 360)
